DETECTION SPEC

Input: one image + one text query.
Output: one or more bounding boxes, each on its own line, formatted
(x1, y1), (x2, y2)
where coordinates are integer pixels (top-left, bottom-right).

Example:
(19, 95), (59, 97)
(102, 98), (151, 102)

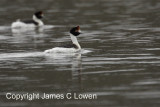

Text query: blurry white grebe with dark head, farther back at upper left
(11, 11), (44, 28)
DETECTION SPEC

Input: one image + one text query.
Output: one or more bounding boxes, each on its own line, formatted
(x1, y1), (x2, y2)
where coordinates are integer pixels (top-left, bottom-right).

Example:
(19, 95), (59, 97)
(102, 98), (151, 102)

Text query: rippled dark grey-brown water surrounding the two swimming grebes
(0, 0), (160, 107)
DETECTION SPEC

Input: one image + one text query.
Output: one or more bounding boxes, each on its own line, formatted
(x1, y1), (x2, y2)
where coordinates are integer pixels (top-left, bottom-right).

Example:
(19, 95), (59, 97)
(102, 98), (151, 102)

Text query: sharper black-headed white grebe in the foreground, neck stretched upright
(45, 26), (81, 53)
